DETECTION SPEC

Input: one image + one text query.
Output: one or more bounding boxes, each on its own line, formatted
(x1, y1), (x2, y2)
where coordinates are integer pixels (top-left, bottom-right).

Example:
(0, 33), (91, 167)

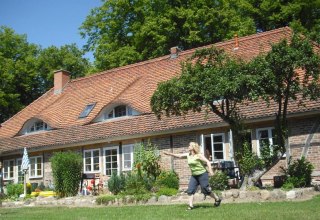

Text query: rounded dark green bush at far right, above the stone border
(283, 157), (314, 188)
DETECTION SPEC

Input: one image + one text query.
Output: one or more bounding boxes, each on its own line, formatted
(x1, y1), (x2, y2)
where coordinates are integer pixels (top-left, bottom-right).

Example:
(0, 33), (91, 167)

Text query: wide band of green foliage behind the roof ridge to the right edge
(80, 0), (320, 70)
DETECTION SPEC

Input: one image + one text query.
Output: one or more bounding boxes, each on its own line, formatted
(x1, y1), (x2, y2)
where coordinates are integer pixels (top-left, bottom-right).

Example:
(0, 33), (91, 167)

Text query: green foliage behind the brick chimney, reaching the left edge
(0, 26), (90, 122)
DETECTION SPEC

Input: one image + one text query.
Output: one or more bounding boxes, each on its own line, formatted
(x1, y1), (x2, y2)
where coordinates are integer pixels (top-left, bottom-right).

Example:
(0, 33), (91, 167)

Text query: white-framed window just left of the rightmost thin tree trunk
(257, 128), (276, 156)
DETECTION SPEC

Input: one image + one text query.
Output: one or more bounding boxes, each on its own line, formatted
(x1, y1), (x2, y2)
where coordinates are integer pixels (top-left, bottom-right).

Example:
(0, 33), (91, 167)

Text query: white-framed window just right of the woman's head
(203, 134), (225, 161)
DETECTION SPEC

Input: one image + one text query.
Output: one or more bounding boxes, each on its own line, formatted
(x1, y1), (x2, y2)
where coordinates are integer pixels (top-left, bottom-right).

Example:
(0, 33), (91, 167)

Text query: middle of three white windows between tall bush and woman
(103, 147), (119, 176)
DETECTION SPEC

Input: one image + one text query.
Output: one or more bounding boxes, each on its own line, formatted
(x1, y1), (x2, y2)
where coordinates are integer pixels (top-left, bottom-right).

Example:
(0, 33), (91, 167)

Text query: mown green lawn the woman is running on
(0, 196), (320, 220)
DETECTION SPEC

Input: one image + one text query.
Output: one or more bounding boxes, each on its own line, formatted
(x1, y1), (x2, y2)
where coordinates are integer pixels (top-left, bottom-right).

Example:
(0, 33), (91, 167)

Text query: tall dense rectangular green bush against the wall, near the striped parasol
(50, 152), (83, 197)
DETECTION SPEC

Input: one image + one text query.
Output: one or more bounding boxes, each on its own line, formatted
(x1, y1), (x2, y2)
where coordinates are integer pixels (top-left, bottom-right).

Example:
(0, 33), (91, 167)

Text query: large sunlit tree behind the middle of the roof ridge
(80, 0), (255, 70)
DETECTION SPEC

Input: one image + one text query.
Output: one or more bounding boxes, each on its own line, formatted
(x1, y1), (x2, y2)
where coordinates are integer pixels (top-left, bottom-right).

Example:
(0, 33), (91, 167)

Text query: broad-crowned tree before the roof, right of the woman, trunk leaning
(151, 47), (259, 151)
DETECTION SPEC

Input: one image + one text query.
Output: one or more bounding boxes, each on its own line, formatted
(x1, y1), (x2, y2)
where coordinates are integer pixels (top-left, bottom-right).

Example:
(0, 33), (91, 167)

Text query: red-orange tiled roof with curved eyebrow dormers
(0, 28), (319, 153)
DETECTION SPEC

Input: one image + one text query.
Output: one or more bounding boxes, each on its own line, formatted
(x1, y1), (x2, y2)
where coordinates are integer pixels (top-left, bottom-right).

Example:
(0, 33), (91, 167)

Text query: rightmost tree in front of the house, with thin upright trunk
(252, 35), (320, 153)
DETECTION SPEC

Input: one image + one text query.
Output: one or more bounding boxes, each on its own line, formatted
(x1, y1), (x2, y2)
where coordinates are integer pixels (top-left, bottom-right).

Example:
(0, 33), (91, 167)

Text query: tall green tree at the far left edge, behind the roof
(0, 26), (39, 122)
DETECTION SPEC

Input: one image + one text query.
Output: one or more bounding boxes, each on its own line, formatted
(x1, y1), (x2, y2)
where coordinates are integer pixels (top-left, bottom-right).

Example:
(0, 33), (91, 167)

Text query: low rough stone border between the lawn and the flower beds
(2, 187), (320, 207)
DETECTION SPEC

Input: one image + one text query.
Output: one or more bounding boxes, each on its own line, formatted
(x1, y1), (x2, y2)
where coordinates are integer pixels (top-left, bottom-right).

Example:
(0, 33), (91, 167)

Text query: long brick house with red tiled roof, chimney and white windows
(0, 28), (320, 187)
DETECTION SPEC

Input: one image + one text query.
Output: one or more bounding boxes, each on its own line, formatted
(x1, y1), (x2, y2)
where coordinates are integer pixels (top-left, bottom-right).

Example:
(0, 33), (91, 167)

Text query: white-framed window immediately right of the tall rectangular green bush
(83, 149), (100, 173)
